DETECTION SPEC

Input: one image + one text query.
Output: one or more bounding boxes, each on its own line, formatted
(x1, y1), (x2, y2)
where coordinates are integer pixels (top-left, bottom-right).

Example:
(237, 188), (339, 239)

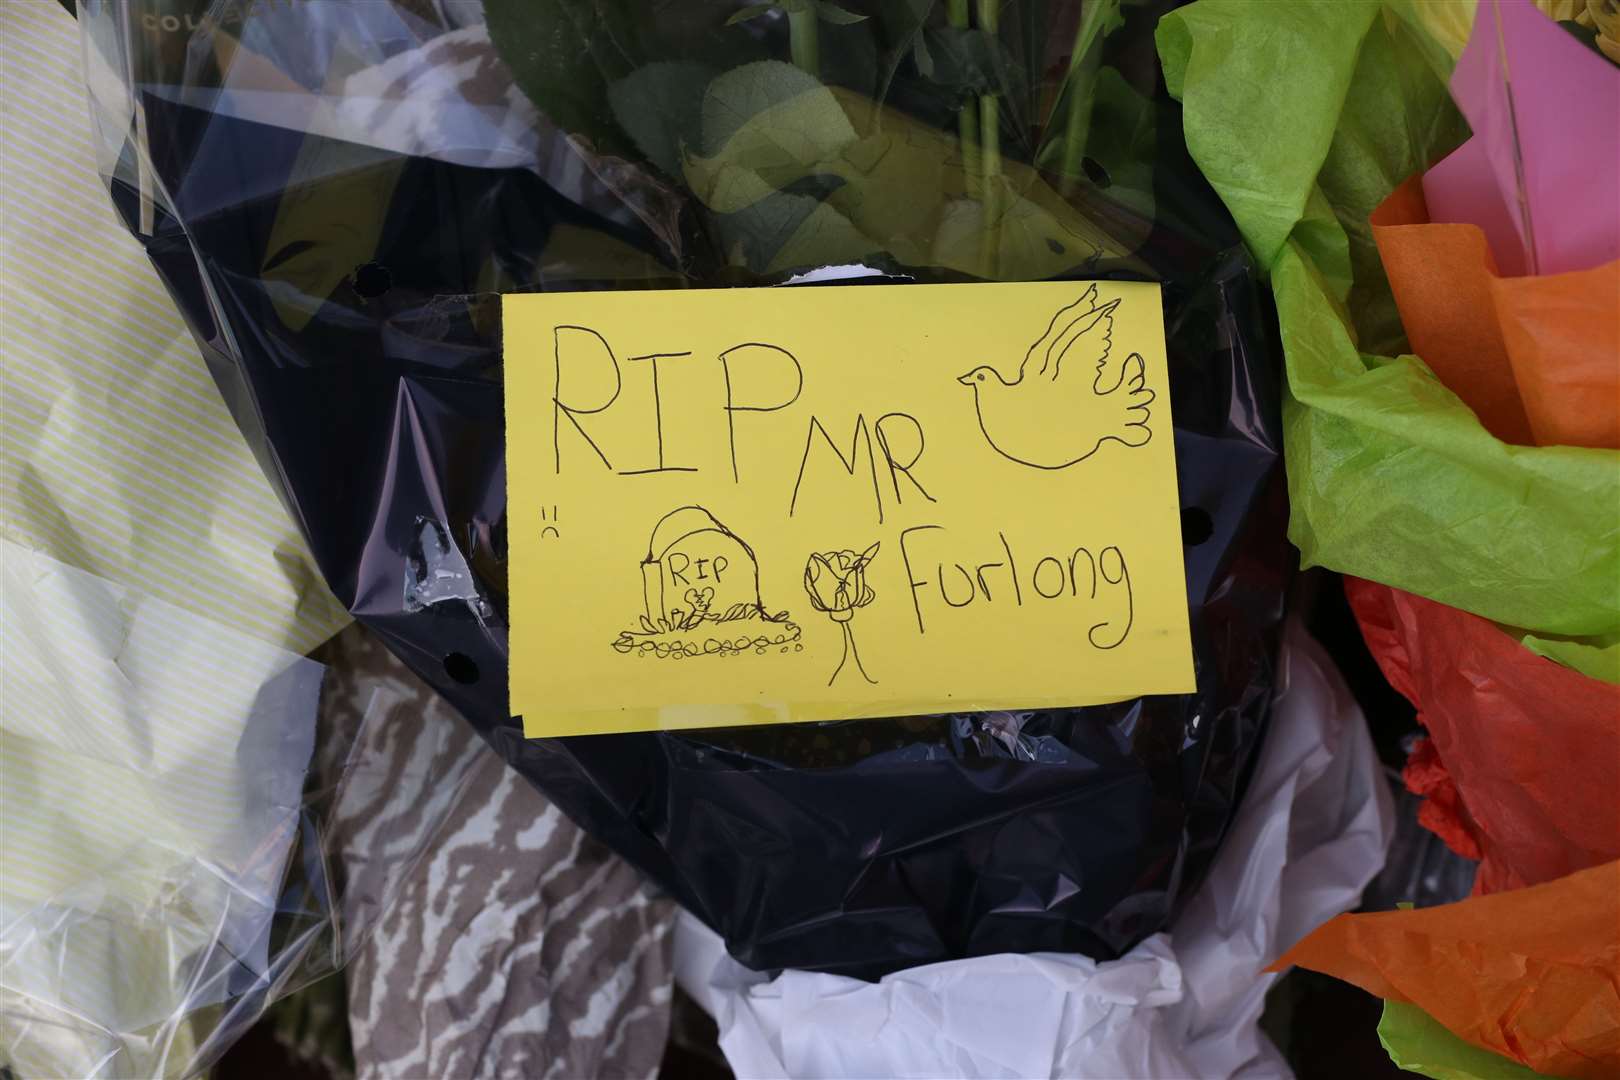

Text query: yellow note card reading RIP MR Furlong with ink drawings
(504, 282), (1194, 737)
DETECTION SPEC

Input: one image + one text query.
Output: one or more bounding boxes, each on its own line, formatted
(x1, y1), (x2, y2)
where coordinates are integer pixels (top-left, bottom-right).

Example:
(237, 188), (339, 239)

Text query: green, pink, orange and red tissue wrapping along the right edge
(1158, 0), (1620, 1077)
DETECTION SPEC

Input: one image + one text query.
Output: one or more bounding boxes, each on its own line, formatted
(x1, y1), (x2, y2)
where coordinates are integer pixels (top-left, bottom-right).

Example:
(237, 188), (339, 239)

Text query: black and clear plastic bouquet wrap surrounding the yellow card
(81, 0), (1293, 978)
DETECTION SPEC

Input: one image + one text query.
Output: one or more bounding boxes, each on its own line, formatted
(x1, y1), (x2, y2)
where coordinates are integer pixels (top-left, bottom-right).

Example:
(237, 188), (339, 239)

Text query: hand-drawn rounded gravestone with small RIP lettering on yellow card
(642, 507), (761, 627)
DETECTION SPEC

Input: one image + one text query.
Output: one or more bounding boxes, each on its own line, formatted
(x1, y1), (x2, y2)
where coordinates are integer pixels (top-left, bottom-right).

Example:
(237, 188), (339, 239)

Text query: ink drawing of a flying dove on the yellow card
(957, 285), (1153, 470)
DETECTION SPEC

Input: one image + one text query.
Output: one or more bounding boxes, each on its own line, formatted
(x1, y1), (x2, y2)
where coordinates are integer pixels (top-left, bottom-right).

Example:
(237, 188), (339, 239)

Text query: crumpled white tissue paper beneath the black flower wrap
(676, 625), (1393, 1078)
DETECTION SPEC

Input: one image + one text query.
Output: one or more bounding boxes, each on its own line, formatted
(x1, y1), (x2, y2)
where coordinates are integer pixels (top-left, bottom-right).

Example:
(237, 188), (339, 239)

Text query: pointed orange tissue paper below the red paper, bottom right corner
(1278, 861), (1620, 1080)
